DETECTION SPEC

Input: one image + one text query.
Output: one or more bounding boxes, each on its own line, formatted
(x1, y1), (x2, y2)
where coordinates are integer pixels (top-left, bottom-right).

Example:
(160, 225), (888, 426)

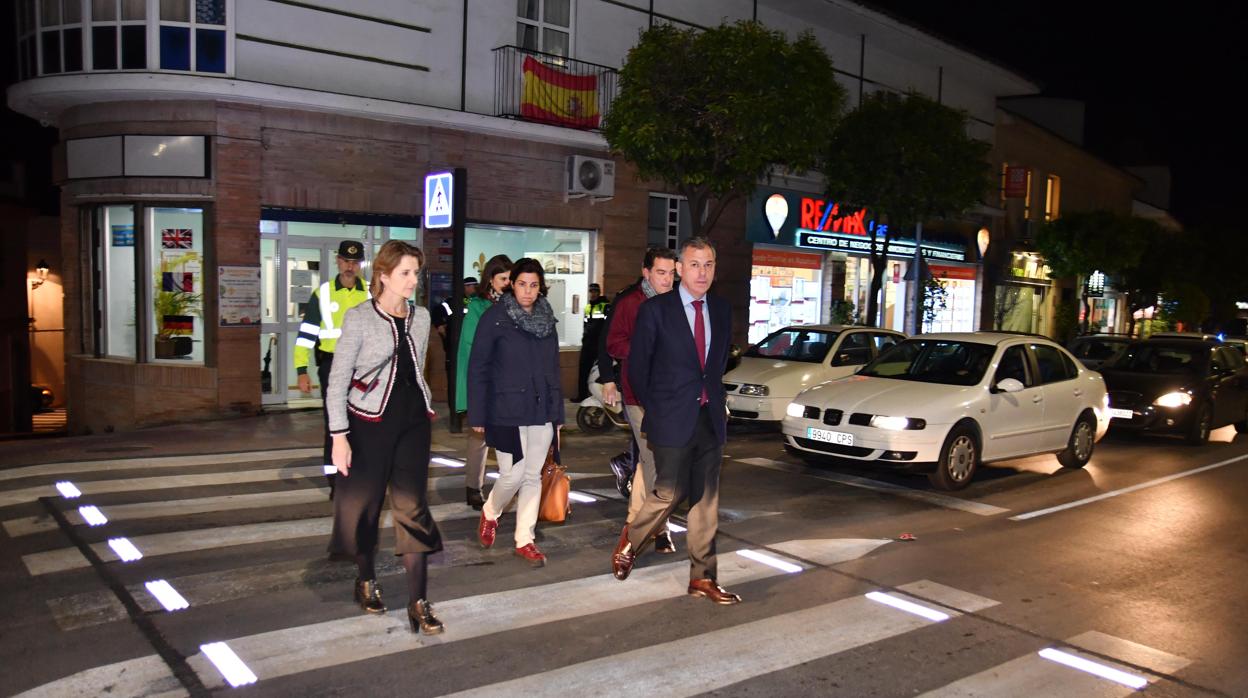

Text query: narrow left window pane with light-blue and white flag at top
(95, 206), (137, 360)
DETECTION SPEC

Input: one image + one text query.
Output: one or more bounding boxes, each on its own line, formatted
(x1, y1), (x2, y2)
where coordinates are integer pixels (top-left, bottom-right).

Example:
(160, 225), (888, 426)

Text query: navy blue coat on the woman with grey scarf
(468, 303), (563, 427)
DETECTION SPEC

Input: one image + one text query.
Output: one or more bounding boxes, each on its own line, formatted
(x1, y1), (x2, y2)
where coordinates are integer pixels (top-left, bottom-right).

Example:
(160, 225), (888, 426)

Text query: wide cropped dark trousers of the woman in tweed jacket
(329, 381), (442, 558)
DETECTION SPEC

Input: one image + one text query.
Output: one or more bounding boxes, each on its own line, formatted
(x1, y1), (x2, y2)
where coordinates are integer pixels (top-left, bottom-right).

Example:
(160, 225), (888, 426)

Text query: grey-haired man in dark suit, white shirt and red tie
(612, 237), (741, 606)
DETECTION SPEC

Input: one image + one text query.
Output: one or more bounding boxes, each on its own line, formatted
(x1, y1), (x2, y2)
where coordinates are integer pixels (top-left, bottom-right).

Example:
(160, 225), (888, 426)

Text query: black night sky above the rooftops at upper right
(869, 0), (1248, 231)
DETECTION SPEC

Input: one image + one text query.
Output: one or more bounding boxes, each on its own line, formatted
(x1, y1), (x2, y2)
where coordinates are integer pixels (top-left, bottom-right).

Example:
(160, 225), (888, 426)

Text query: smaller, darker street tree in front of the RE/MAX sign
(824, 92), (991, 325)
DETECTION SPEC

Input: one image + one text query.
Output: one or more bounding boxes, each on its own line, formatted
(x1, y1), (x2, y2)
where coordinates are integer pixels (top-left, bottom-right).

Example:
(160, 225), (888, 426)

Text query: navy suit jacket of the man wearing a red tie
(628, 290), (733, 447)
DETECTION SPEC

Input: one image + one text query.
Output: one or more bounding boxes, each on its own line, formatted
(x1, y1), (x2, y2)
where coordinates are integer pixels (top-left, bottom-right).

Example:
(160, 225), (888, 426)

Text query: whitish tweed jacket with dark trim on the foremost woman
(324, 300), (433, 433)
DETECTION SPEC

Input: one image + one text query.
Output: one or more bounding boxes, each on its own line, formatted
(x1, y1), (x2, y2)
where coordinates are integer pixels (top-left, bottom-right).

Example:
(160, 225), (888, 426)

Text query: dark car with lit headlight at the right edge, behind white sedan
(1101, 338), (1248, 443)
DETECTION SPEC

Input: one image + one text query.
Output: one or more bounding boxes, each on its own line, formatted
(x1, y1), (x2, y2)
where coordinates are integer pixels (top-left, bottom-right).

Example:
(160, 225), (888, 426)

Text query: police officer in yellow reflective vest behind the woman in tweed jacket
(295, 240), (369, 499)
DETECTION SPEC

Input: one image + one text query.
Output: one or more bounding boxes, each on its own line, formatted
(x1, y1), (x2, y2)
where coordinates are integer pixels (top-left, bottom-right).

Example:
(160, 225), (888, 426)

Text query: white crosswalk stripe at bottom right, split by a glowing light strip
(922, 631), (1191, 698)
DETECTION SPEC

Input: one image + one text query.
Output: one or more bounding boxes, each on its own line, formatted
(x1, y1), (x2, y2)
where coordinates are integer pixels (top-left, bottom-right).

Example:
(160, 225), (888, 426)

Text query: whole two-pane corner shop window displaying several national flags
(94, 205), (205, 363)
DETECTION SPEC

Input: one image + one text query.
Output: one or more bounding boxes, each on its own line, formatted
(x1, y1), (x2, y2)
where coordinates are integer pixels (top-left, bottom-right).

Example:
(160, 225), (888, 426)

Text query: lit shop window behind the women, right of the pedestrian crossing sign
(459, 225), (594, 347)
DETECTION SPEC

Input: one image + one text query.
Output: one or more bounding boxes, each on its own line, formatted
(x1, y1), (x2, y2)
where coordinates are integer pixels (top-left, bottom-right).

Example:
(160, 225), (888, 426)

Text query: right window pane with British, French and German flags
(146, 209), (203, 363)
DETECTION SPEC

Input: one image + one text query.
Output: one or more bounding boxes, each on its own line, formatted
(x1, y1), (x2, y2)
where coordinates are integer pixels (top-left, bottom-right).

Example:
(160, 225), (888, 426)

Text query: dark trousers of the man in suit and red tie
(629, 405), (724, 579)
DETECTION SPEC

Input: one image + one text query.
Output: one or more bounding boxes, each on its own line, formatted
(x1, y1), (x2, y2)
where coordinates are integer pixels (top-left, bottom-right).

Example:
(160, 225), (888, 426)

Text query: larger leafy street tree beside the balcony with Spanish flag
(603, 21), (845, 235)
